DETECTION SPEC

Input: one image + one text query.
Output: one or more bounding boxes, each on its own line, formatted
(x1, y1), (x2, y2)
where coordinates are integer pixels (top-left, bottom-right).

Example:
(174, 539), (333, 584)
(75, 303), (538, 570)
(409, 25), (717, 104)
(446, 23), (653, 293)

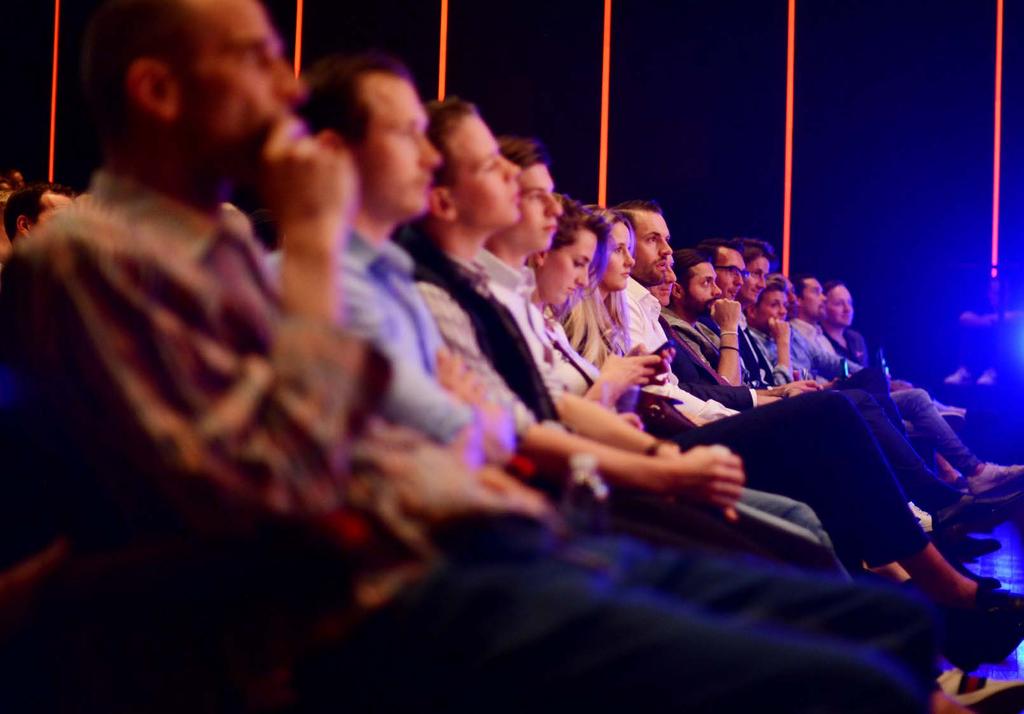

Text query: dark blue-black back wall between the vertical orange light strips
(0, 0), (1024, 381)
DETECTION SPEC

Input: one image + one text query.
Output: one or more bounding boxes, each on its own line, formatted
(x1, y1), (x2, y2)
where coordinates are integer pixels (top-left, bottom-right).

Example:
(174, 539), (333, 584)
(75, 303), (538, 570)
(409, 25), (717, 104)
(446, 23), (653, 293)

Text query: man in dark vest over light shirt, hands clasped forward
(401, 99), (757, 501)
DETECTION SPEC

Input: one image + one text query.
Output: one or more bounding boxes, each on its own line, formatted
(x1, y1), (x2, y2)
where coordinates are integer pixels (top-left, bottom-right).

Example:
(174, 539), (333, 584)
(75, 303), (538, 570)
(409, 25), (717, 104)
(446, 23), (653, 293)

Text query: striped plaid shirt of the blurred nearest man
(2, 172), (432, 604)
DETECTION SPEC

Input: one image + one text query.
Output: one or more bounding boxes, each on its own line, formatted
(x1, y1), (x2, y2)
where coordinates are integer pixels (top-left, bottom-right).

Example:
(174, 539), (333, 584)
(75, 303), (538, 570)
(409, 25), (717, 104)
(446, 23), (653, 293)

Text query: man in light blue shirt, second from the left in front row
(296, 56), (520, 463)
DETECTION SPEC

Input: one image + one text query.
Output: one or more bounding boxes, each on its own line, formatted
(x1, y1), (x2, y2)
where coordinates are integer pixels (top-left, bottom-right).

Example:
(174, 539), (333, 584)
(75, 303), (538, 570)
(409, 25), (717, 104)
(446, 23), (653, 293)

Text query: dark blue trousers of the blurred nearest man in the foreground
(298, 520), (934, 714)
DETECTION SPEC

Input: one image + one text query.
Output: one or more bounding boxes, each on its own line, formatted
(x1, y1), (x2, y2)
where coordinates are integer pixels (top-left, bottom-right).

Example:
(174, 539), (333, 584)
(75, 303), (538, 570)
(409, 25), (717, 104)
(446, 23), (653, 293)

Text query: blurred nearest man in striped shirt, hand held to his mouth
(0, 5), (950, 712)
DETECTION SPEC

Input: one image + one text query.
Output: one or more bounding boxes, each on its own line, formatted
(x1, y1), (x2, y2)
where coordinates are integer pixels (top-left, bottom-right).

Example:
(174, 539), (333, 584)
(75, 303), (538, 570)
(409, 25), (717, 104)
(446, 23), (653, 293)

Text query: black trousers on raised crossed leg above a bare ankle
(675, 391), (928, 572)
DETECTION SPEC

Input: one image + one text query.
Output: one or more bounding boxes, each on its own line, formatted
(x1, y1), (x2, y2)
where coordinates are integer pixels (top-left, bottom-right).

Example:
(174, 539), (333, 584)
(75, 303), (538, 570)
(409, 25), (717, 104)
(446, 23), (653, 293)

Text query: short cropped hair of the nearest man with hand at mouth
(82, 0), (196, 138)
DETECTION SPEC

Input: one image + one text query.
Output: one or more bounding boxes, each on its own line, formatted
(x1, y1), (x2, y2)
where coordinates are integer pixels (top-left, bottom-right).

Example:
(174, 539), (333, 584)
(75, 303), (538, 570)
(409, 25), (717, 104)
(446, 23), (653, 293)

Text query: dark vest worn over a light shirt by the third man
(395, 227), (558, 421)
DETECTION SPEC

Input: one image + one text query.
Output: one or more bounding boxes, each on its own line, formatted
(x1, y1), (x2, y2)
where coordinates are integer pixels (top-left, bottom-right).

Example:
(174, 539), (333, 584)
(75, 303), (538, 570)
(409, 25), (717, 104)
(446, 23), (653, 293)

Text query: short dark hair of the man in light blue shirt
(301, 51), (414, 142)
